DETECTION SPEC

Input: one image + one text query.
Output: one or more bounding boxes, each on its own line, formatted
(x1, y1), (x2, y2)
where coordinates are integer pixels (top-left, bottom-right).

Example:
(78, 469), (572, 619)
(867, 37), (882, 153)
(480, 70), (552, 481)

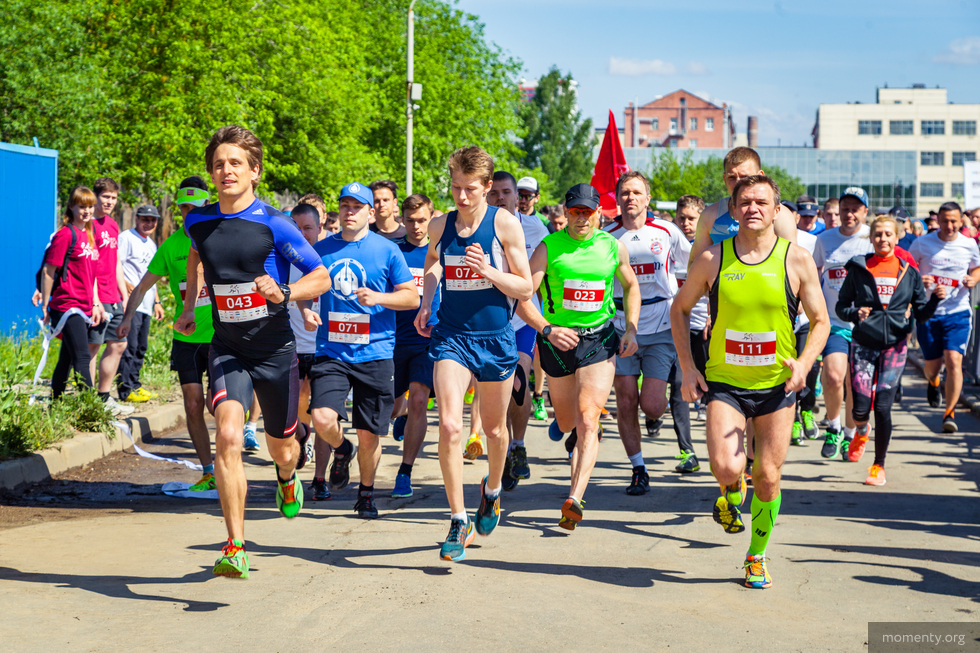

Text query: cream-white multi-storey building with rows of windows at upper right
(813, 84), (980, 216)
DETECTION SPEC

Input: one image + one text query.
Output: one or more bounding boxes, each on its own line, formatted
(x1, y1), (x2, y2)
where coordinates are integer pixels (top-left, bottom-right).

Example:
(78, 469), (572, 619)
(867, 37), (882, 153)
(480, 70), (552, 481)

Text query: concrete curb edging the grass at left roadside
(0, 403), (184, 490)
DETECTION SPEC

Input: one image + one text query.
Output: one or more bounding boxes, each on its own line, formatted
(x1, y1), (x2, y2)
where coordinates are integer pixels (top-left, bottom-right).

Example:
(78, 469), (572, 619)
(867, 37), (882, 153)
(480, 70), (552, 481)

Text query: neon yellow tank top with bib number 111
(707, 238), (799, 390)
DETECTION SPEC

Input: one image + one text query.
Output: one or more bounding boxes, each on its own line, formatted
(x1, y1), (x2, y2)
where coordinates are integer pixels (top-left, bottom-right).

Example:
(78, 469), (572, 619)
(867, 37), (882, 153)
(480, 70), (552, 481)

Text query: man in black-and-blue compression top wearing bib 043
(174, 125), (330, 578)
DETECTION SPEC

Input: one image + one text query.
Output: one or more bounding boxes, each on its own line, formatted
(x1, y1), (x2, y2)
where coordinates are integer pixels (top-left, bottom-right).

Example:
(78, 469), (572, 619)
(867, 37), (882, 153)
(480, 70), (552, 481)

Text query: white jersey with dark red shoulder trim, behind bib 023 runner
(606, 218), (691, 336)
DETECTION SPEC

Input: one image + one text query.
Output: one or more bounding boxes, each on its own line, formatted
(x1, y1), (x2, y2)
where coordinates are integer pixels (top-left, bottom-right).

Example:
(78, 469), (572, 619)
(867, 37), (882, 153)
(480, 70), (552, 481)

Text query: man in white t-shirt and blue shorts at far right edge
(910, 202), (980, 433)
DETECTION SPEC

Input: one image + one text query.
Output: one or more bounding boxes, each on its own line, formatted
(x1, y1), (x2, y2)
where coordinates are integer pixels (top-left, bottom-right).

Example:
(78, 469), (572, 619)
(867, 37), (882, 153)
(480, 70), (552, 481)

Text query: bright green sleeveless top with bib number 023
(541, 229), (619, 328)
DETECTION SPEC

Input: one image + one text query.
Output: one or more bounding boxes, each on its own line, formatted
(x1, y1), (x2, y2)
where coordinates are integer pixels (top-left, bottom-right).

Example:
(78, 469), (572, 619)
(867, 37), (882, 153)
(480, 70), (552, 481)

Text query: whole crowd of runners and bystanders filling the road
(35, 126), (980, 588)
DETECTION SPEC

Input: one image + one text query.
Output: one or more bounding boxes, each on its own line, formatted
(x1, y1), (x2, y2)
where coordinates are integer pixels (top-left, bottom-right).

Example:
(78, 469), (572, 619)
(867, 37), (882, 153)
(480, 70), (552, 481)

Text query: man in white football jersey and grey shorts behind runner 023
(606, 171), (691, 496)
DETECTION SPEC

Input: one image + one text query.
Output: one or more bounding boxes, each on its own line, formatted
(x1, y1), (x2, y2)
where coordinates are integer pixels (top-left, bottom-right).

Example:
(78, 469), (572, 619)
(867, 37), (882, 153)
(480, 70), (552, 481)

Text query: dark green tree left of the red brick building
(520, 68), (594, 197)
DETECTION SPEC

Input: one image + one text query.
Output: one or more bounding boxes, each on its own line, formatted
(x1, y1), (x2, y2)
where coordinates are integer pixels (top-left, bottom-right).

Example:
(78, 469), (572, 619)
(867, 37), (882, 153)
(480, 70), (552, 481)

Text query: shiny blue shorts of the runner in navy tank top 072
(429, 324), (517, 382)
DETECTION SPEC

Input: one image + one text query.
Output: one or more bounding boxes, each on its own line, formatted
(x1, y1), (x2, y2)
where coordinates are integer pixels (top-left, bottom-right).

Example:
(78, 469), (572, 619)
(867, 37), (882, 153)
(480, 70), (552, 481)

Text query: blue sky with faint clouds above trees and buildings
(450, 0), (980, 146)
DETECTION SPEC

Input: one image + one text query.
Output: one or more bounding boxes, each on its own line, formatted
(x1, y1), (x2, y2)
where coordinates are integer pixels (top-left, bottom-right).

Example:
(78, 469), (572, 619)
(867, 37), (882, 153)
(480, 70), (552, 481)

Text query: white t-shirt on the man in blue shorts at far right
(909, 231), (980, 315)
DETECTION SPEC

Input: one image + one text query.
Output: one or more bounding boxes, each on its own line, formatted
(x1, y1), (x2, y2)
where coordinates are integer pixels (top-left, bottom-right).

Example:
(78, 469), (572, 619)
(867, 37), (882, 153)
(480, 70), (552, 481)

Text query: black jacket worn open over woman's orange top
(835, 254), (939, 349)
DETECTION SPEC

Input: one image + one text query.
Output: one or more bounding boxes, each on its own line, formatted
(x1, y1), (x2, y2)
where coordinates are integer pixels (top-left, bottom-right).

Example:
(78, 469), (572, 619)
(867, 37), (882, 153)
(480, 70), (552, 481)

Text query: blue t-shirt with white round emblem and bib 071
(313, 231), (412, 363)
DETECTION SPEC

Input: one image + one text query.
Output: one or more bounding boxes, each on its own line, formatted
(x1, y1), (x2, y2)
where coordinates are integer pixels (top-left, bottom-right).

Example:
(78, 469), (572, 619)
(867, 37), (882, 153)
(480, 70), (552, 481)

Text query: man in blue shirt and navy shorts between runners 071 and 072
(391, 194), (439, 499)
